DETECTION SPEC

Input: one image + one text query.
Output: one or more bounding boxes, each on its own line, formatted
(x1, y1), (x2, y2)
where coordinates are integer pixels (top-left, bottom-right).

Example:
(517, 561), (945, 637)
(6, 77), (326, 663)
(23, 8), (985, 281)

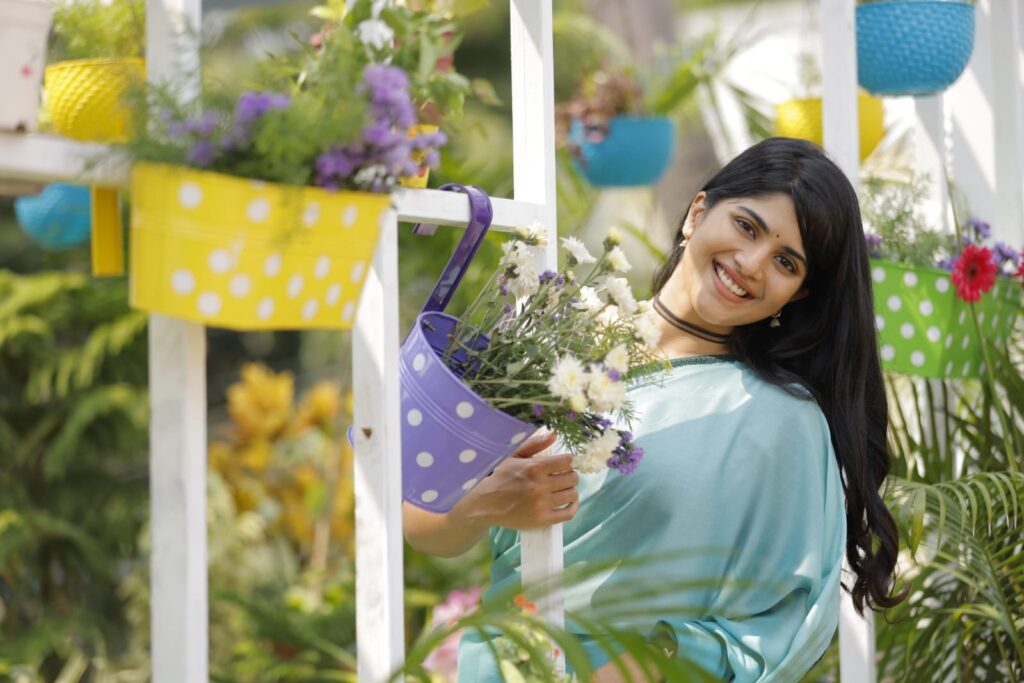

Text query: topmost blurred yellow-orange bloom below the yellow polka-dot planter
(227, 362), (295, 440)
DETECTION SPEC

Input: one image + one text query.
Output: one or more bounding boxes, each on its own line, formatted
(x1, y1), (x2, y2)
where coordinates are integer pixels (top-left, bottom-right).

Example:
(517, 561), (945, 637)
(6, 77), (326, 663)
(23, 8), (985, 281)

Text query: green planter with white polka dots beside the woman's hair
(871, 259), (1021, 378)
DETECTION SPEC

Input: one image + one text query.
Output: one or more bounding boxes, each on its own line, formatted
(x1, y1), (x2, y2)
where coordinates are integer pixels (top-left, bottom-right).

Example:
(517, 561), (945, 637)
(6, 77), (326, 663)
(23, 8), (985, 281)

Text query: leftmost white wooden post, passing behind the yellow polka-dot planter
(145, 0), (209, 683)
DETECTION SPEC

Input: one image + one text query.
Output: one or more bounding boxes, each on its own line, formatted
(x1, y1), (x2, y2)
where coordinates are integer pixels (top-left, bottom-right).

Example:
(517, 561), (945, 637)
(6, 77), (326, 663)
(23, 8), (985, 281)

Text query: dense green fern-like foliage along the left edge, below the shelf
(0, 270), (147, 681)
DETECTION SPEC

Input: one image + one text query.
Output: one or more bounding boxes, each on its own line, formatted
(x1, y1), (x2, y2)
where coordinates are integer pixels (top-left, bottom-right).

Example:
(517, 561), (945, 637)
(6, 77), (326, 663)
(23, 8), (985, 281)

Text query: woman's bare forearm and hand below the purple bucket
(402, 432), (580, 557)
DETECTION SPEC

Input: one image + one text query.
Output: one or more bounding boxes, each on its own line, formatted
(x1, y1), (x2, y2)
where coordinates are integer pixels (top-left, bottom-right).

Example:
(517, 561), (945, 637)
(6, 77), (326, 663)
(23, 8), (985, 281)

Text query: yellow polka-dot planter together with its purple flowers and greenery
(114, 22), (442, 329)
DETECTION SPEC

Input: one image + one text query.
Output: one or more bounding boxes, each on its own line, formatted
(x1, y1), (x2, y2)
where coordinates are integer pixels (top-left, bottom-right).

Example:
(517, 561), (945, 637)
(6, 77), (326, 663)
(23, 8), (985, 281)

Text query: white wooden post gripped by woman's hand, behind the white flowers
(510, 0), (565, 627)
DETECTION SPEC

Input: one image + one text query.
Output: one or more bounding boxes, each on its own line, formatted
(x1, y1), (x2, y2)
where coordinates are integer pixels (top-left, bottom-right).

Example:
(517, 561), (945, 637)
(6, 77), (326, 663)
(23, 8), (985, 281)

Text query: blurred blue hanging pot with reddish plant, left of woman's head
(569, 116), (675, 187)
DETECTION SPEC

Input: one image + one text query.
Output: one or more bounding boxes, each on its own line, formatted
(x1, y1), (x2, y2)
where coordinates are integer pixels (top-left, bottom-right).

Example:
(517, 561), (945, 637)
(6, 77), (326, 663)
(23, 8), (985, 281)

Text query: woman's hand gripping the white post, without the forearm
(452, 432), (580, 529)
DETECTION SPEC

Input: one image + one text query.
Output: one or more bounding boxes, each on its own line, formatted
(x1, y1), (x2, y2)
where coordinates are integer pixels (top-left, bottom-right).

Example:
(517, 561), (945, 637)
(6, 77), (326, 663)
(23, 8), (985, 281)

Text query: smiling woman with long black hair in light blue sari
(406, 138), (902, 681)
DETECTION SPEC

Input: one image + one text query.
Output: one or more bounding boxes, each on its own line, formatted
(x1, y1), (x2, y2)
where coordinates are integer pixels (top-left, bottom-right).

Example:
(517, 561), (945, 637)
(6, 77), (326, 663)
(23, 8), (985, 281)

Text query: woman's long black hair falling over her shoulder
(652, 137), (905, 613)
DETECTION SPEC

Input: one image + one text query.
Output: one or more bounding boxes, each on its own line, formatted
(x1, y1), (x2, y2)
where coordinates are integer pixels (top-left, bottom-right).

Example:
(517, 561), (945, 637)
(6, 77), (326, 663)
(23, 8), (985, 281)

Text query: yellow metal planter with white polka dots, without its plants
(130, 164), (390, 330)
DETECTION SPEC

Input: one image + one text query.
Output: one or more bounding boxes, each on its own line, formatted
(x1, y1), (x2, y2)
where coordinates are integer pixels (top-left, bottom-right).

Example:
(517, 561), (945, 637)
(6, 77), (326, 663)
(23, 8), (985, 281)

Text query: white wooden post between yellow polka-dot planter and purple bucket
(352, 211), (404, 683)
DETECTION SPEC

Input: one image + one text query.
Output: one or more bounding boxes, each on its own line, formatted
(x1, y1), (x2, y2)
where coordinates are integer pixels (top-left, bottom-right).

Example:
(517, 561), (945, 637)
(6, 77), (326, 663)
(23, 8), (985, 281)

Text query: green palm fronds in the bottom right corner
(879, 472), (1024, 683)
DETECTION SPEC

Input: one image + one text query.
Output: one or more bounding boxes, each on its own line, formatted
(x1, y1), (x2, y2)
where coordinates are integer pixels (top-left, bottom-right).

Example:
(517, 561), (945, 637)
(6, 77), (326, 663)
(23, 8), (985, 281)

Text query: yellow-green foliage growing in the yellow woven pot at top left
(50, 0), (145, 61)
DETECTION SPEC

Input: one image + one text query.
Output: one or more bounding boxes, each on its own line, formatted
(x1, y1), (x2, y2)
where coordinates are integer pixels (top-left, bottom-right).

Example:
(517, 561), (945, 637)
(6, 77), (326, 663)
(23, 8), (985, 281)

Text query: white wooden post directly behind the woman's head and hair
(819, 0), (876, 683)
